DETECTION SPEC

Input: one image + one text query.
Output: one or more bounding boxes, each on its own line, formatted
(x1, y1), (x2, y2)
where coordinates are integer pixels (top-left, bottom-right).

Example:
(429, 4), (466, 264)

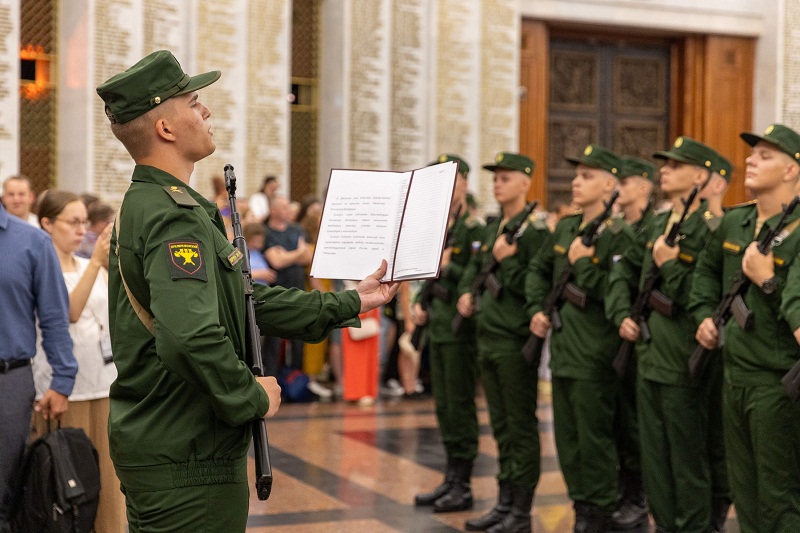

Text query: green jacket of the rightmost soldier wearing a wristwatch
(689, 203), (800, 386)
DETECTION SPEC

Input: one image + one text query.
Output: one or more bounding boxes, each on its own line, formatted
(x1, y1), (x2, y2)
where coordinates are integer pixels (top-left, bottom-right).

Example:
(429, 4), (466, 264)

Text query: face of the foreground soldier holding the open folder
(170, 92), (217, 162)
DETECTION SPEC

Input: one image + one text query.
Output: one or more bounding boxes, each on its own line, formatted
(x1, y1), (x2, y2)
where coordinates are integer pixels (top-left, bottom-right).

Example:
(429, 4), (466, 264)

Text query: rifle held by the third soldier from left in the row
(521, 191), (619, 364)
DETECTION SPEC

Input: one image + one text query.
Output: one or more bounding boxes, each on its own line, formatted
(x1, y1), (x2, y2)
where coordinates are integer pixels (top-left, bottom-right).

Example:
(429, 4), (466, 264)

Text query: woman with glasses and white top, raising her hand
(33, 189), (127, 533)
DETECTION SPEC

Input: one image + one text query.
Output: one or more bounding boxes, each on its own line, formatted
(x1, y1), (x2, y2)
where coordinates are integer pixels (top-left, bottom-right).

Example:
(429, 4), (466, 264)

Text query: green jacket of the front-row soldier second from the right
(606, 202), (720, 385)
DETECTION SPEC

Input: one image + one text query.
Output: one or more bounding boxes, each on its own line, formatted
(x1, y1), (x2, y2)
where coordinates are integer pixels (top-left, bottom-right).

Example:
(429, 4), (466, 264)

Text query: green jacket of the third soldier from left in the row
(525, 210), (633, 380)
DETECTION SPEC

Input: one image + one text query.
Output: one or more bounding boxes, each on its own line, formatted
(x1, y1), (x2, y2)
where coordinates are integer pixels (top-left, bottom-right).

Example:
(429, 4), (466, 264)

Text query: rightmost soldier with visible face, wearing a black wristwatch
(689, 124), (800, 533)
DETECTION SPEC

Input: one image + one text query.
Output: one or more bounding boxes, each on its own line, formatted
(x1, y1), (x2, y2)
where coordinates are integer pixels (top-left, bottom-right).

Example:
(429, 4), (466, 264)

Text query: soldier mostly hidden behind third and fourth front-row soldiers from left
(612, 156), (656, 530)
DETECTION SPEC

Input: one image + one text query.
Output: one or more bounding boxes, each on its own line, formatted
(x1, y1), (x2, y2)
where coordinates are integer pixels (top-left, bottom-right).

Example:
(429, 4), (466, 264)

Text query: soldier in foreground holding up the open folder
(97, 50), (397, 532)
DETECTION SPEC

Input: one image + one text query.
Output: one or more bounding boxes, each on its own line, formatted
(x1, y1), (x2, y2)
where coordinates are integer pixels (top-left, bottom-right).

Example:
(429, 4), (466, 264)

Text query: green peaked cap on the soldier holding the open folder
(97, 50), (221, 124)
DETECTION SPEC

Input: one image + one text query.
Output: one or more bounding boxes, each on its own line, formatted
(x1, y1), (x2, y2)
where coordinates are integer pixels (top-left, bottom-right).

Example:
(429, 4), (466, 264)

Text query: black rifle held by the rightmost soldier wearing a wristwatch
(689, 196), (800, 378)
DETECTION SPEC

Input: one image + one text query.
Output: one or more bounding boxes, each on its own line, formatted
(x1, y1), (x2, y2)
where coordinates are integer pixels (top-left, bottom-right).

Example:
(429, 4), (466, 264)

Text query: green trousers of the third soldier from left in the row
(553, 376), (619, 513)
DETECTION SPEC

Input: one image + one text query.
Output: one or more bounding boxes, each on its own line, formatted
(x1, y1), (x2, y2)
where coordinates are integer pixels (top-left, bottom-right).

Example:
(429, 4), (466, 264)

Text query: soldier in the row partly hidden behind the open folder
(412, 154), (484, 512)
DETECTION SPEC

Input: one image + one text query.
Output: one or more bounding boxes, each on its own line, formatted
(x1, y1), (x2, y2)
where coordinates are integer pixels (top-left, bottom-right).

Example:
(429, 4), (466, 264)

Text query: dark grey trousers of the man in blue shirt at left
(0, 365), (36, 531)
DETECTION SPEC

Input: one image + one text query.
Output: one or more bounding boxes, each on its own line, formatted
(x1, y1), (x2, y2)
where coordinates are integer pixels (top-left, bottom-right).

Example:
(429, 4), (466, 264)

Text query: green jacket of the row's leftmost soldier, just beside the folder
(416, 214), (486, 342)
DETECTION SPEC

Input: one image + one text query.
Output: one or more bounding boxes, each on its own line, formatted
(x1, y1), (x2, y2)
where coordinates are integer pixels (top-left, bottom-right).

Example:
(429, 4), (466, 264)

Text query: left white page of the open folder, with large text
(311, 169), (411, 281)
